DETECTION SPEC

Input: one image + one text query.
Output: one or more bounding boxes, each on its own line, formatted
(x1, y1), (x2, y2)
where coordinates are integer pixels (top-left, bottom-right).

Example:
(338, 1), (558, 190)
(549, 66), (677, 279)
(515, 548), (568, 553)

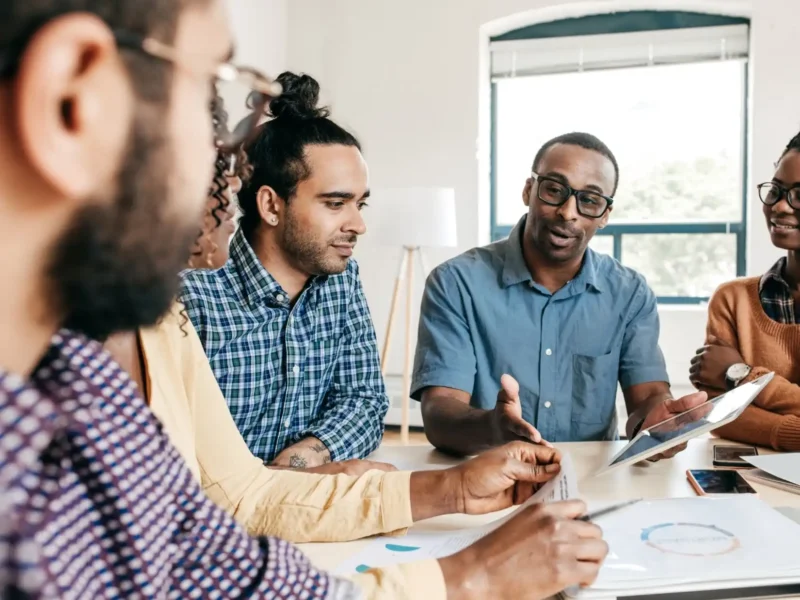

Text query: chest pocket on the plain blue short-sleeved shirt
(572, 348), (620, 441)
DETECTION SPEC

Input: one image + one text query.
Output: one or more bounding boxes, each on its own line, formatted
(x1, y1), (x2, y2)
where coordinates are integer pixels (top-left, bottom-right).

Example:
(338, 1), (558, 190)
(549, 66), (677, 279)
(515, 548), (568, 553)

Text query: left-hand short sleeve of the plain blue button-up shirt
(411, 264), (476, 400)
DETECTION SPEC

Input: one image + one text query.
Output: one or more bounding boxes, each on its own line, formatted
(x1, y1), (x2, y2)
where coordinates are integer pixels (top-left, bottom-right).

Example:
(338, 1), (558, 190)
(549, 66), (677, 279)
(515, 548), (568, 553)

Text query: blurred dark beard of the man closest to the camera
(48, 104), (202, 340)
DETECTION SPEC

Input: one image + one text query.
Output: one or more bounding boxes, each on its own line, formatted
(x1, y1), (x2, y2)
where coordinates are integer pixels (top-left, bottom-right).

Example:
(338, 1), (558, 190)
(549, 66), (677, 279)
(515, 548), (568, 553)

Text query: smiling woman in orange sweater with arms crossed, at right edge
(690, 134), (800, 451)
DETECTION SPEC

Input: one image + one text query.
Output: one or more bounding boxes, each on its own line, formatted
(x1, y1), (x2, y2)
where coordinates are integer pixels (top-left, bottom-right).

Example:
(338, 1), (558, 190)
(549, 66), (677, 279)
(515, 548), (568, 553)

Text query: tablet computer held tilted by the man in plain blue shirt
(598, 373), (775, 475)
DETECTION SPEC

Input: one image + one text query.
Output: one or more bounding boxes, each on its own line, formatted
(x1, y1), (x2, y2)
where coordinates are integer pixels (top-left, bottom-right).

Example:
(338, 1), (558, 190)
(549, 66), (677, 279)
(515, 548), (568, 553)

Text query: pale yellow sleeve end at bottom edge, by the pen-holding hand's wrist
(352, 560), (447, 600)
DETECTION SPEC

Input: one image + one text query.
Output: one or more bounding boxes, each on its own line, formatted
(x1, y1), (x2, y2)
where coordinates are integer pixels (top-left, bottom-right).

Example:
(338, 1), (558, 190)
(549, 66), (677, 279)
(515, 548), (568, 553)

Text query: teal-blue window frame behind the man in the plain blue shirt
(489, 11), (750, 305)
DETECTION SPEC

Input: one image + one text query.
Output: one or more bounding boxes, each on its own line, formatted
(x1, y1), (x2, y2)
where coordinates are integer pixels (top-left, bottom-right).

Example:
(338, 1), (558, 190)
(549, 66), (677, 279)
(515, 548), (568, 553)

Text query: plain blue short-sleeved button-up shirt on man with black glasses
(412, 219), (668, 442)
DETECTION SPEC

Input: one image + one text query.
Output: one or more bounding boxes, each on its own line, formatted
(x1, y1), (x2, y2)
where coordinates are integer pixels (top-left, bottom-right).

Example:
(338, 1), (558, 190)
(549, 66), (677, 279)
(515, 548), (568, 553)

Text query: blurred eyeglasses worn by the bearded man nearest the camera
(0, 29), (283, 152)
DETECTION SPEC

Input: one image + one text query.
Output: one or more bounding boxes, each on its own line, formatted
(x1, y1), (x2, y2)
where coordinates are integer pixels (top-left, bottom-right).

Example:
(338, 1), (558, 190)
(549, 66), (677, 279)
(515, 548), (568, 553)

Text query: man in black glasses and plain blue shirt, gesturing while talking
(411, 133), (706, 458)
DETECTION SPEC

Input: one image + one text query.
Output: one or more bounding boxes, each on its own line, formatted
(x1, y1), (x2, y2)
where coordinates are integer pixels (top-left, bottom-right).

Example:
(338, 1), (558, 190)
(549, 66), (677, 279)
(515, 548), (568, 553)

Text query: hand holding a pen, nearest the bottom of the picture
(439, 500), (608, 600)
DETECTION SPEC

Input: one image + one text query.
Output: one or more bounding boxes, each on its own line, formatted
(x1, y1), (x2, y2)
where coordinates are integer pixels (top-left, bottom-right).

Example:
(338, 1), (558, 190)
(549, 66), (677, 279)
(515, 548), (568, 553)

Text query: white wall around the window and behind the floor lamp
(280, 0), (800, 392)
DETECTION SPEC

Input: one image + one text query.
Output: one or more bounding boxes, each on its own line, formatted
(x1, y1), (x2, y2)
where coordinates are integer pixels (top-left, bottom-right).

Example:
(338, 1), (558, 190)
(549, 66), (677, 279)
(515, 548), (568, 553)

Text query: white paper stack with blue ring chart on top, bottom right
(564, 495), (800, 600)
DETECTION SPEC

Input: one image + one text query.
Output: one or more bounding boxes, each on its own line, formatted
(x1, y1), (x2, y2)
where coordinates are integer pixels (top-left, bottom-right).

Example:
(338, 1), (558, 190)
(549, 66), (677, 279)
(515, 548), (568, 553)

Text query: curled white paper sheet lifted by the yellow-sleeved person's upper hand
(336, 454), (578, 575)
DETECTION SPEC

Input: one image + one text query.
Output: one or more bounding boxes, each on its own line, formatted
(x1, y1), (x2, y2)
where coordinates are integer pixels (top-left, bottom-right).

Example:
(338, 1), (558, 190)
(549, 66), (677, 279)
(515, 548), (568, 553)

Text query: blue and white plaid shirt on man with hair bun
(181, 230), (389, 462)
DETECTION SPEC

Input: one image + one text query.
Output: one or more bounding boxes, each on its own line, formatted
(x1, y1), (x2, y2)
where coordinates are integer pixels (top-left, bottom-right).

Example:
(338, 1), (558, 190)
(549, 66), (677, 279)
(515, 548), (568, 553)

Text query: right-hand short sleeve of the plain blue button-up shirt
(619, 278), (669, 390)
